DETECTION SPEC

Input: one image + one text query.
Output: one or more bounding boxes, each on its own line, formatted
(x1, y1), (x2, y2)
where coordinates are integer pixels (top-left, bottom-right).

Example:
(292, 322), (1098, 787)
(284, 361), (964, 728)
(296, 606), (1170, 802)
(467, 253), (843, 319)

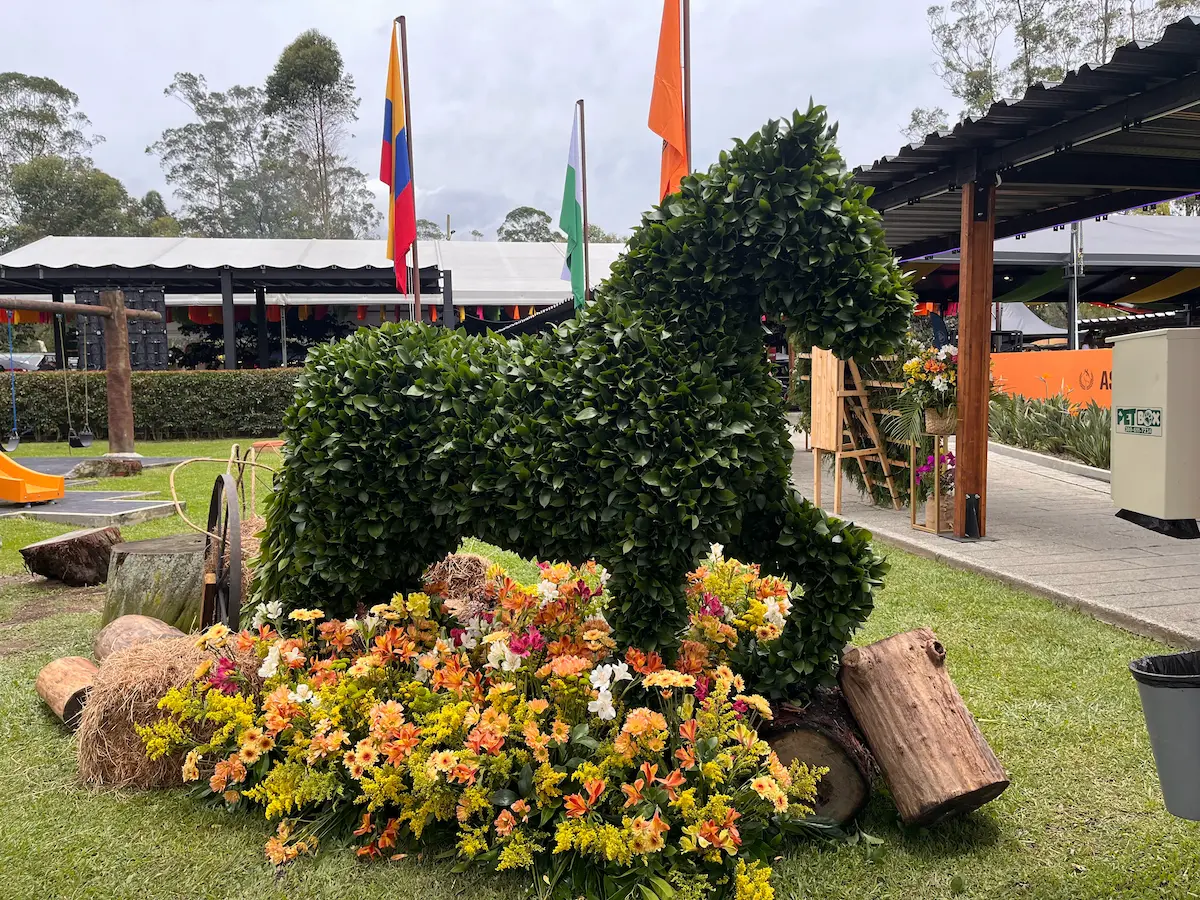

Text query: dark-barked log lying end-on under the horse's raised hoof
(766, 688), (875, 824)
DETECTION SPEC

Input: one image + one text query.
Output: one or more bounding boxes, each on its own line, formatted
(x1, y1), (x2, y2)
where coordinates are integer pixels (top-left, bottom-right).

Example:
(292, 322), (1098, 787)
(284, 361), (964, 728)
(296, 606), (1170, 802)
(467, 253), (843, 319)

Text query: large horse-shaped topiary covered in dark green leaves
(258, 107), (912, 696)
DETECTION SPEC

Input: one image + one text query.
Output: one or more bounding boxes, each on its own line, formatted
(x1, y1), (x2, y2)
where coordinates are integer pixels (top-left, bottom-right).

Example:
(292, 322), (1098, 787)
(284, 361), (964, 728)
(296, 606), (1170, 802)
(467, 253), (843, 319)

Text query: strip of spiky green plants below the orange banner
(988, 394), (1112, 469)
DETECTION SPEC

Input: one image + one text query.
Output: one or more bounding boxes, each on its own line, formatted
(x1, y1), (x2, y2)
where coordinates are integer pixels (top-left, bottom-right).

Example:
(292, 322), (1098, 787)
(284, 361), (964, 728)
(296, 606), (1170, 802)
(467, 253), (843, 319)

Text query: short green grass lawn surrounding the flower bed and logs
(0, 442), (1200, 900)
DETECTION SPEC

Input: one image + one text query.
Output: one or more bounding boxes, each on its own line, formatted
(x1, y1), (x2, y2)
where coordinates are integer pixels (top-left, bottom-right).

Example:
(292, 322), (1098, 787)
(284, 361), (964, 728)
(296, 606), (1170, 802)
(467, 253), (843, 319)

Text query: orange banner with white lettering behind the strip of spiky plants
(991, 349), (1112, 407)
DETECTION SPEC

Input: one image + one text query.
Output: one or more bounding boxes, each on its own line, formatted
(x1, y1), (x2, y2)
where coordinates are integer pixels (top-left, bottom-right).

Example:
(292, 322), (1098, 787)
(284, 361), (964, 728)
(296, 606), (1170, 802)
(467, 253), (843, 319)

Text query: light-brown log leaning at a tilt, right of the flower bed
(841, 628), (1008, 826)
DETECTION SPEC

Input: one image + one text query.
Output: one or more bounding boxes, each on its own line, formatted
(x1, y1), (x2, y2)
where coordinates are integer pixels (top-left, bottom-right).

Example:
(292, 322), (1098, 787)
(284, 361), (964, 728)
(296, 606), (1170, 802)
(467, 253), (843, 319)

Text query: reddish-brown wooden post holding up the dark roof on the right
(954, 179), (996, 538)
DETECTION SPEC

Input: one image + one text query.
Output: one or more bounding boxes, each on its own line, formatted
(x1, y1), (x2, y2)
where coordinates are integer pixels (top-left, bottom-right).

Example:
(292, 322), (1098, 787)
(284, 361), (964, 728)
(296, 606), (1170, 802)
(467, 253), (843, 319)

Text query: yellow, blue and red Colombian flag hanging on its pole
(379, 24), (416, 294)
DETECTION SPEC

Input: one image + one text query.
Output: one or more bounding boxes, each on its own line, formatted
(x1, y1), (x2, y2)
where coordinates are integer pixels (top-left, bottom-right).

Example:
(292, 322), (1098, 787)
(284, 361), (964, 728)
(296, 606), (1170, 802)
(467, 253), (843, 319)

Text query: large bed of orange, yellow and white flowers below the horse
(142, 546), (822, 900)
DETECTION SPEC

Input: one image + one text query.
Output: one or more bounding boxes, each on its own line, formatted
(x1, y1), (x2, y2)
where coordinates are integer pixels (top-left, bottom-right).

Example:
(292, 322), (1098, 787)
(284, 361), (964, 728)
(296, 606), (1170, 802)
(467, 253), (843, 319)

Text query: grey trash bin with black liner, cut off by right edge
(1129, 650), (1200, 821)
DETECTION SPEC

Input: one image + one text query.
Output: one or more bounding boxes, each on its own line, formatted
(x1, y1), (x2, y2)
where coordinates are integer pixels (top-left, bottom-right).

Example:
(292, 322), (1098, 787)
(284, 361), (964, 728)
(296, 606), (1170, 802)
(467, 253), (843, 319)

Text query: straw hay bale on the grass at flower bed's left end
(79, 637), (262, 788)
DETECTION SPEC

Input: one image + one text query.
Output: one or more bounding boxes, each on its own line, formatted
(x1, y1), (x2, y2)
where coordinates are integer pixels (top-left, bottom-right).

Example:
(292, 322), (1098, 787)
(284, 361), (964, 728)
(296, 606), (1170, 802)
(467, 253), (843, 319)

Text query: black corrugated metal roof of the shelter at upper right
(854, 17), (1200, 259)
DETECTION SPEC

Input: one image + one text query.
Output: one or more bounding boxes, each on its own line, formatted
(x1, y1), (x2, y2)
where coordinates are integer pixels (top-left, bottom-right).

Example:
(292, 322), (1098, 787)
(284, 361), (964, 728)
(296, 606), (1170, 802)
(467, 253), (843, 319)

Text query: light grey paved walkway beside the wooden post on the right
(792, 442), (1200, 647)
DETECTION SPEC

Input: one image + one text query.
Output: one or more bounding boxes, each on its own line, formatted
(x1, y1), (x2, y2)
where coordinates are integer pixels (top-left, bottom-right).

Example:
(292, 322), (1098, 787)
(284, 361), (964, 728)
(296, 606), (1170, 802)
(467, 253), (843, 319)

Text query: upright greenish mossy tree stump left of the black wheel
(101, 534), (204, 632)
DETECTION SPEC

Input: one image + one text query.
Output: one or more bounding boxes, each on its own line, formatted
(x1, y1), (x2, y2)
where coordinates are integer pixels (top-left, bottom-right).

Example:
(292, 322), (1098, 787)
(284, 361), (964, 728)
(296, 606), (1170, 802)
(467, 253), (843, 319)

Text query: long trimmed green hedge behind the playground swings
(11, 368), (299, 440)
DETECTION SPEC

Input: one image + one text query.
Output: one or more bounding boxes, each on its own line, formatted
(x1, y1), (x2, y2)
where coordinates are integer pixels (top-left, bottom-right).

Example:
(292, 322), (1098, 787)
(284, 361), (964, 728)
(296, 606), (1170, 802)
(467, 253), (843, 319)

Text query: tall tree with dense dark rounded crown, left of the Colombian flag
(265, 30), (379, 238)
